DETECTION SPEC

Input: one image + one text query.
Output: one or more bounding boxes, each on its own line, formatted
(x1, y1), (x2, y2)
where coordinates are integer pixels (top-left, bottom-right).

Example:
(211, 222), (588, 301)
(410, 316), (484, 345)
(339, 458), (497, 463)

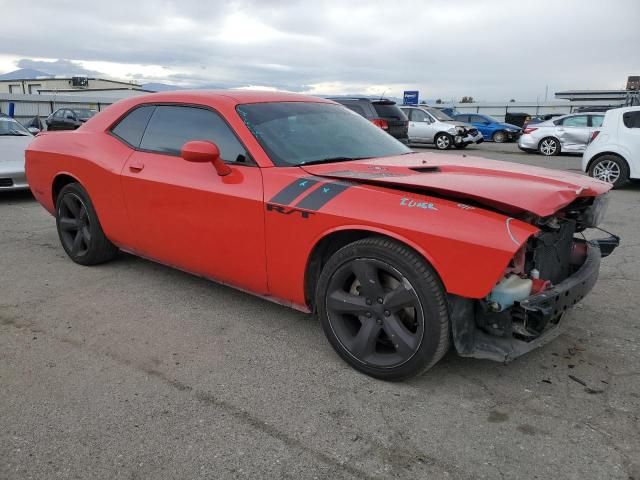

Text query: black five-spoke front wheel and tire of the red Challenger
(316, 237), (450, 380)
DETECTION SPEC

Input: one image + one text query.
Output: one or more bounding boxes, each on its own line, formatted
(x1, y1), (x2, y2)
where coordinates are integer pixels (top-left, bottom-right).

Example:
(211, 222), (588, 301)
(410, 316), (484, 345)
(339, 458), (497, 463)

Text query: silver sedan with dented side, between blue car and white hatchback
(518, 113), (604, 156)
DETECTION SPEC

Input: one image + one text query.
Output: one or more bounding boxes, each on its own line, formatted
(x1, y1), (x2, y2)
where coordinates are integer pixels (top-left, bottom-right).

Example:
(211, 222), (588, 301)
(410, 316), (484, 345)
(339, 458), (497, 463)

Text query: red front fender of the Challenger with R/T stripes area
(264, 169), (538, 305)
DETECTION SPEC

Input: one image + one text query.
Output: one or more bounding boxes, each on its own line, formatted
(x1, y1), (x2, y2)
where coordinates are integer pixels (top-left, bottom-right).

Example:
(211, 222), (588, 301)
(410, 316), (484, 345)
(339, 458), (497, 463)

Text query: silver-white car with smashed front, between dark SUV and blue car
(400, 105), (484, 150)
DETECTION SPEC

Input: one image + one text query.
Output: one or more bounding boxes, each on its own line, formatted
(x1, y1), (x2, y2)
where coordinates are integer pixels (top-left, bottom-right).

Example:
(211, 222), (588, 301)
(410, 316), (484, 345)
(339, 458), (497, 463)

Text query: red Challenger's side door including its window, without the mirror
(121, 105), (267, 294)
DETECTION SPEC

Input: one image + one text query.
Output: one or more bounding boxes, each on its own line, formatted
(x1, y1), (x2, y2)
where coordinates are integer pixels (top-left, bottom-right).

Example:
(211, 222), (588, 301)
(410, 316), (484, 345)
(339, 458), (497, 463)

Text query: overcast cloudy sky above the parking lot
(0, 0), (640, 100)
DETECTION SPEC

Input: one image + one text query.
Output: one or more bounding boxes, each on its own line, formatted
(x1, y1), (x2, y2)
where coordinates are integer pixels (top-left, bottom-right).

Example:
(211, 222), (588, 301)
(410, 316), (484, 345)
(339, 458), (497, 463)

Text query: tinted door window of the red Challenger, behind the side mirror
(140, 105), (247, 162)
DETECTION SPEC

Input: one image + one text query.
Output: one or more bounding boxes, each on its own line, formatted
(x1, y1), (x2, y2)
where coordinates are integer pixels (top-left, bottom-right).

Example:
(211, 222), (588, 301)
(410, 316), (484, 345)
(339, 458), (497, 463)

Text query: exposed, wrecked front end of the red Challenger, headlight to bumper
(450, 196), (619, 362)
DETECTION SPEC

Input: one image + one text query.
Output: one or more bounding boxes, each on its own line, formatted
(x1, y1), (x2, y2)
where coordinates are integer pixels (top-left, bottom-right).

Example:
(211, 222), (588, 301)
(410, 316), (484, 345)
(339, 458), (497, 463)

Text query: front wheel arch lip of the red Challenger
(304, 226), (446, 311)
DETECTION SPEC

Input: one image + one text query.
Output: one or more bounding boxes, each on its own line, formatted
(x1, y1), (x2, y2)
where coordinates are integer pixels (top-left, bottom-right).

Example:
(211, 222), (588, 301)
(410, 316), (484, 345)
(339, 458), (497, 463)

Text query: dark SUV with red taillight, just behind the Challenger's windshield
(329, 97), (409, 144)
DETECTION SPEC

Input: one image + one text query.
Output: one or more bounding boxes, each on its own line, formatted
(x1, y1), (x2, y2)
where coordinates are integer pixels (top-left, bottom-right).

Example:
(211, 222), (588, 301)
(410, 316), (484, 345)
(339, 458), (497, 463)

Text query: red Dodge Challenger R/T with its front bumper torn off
(26, 91), (618, 380)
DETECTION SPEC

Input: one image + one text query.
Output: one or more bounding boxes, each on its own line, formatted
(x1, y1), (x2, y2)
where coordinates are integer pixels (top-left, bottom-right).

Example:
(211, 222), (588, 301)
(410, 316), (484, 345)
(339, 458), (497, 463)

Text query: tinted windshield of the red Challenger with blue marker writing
(237, 102), (411, 167)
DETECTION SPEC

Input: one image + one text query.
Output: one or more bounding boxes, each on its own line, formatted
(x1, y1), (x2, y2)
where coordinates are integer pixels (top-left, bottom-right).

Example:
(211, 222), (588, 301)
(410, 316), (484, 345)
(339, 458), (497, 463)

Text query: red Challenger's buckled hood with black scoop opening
(302, 153), (611, 217)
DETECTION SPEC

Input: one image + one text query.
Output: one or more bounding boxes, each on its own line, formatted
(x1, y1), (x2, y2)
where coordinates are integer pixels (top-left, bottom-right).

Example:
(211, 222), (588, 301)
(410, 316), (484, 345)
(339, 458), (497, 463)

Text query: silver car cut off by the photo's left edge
(0, 113), (33, 191)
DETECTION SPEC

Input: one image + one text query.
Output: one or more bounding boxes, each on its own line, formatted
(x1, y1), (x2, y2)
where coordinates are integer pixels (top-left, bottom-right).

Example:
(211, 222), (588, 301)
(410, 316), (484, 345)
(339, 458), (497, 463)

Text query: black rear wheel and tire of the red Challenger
(56, 183), (118, 265)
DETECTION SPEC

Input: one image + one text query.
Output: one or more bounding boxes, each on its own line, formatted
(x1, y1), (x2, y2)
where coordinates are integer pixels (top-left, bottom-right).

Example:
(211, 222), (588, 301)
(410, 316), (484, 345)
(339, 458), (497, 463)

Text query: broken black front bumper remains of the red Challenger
(449, 236), (619, 362)
